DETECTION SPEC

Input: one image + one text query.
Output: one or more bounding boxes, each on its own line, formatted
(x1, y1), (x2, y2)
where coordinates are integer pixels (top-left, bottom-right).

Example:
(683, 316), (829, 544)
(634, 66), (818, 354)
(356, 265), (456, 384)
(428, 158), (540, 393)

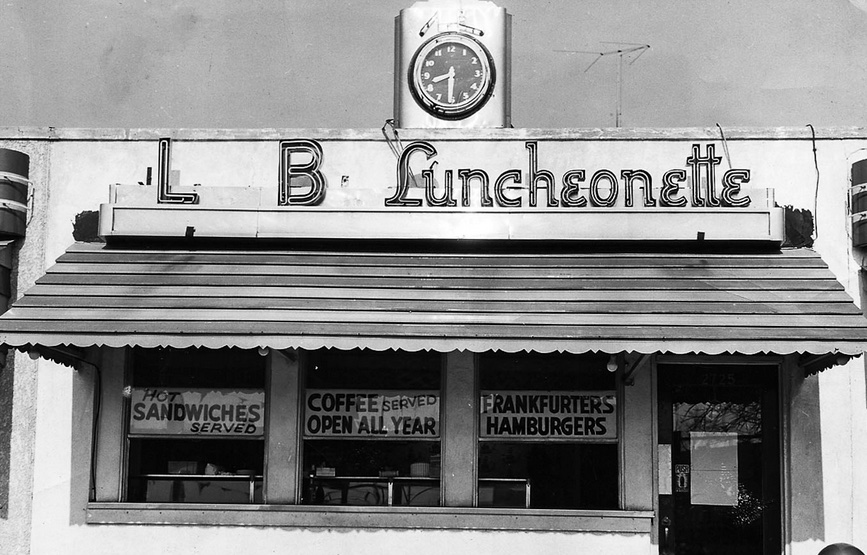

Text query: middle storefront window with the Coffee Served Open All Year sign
(302, 350), (441, 506)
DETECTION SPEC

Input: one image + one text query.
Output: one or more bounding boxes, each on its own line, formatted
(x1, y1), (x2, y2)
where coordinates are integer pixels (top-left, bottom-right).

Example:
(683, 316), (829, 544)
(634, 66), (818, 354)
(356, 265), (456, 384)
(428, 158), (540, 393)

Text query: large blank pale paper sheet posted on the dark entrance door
(689, 432), (738, 507)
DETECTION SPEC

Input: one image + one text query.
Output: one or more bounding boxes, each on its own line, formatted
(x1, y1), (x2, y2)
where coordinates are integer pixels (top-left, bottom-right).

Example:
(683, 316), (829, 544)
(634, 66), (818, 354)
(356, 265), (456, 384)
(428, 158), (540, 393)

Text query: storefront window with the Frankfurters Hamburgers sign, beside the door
(478, 353), (619, 509)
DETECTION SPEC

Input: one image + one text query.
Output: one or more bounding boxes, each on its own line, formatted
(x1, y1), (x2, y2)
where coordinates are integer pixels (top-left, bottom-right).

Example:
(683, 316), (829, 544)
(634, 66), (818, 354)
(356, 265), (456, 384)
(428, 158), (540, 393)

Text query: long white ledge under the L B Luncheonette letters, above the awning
(99, 204), (783, 243)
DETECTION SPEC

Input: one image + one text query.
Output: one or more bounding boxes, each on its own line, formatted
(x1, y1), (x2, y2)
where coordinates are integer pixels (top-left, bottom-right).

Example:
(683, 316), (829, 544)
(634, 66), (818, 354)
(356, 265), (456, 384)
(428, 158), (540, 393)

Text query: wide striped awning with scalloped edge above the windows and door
(0, 244), (867, 355)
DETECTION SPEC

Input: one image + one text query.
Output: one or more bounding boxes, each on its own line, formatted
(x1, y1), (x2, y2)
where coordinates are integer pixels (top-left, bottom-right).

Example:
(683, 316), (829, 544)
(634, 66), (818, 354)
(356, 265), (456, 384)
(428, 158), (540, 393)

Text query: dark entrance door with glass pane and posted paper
(658, 365), (781, 555)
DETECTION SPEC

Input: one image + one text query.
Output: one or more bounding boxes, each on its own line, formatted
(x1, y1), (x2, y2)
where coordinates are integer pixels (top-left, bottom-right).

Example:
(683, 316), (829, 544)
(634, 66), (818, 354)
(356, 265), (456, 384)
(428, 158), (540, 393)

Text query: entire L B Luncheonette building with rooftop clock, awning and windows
(0, 2), (867, 555)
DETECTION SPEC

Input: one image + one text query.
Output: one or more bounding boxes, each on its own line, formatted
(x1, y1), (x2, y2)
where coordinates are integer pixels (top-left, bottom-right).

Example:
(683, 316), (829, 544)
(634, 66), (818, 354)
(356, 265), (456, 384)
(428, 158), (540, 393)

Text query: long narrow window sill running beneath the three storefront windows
(87, 503), (653, 534)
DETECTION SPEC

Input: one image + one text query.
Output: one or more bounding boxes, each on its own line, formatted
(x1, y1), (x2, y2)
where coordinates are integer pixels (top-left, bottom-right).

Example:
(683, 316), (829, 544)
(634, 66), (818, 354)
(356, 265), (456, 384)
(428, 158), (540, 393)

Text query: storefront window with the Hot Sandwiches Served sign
(127, 349), (265, 503)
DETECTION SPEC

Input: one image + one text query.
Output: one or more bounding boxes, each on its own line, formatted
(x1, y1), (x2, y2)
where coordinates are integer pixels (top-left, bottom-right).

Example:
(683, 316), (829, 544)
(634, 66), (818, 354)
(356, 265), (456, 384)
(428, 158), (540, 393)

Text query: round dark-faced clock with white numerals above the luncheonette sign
(409, 33), (494, 119)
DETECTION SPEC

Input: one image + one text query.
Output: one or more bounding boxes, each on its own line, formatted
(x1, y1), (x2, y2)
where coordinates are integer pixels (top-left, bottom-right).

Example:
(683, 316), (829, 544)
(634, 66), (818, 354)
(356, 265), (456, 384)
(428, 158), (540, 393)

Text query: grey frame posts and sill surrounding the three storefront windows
(83, 348), (654, 534)
